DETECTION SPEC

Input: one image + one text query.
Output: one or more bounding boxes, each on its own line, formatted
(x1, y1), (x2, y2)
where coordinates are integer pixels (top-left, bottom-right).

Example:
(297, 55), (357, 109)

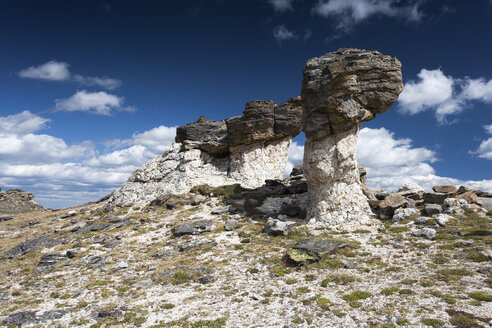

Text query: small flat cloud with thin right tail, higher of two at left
(19, 60), (121, 90)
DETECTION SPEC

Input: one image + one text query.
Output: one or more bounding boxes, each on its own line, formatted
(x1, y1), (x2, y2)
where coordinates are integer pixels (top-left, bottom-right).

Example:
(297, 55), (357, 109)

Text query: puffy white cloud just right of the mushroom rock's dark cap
(398, 68), (492, 123)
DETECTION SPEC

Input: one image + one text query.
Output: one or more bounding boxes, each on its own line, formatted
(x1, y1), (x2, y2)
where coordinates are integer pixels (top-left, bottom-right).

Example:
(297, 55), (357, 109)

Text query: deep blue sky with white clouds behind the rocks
(0, 0), (492, 207)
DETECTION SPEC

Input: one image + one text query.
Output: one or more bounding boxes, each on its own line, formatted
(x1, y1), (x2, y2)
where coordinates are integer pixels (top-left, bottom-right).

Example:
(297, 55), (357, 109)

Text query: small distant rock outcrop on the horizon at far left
(0, 189), (43, 214)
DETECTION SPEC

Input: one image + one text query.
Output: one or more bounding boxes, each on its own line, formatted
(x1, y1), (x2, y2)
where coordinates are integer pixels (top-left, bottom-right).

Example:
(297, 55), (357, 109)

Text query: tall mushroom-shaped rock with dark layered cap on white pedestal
(302, 49), (403, 225)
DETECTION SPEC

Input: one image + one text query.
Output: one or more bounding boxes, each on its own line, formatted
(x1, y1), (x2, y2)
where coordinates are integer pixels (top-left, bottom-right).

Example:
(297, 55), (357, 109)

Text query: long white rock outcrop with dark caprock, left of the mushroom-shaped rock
(108, 97), (302, 205)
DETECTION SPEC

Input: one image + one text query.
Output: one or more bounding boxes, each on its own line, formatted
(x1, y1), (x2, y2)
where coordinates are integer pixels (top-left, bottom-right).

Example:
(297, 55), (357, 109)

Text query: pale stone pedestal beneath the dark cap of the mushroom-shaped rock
(304, 126), (372, 225)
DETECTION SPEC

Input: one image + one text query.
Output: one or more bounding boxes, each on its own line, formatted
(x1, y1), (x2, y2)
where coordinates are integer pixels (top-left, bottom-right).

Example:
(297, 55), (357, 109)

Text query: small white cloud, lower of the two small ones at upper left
(55, 90), (135, 115)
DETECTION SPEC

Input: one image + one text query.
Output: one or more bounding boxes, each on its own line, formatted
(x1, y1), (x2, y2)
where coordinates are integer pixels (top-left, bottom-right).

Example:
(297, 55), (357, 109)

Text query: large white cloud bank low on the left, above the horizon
(0, 111), (176, 207)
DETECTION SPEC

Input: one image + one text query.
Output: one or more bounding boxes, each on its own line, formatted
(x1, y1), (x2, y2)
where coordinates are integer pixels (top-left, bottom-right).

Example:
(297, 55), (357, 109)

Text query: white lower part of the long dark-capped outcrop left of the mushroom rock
(108, 138), (291, 206)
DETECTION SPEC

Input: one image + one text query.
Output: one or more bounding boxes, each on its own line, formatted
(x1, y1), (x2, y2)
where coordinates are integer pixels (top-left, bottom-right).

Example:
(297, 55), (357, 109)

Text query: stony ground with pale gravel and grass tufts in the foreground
(0, 188), (492, 327)
